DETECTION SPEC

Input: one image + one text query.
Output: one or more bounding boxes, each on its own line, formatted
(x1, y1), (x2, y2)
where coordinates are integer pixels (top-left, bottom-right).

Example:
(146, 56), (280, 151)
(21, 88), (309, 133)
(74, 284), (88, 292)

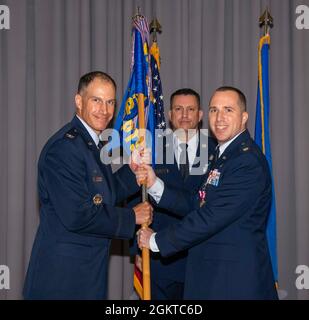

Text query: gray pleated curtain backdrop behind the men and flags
(0, 0), (309, 299)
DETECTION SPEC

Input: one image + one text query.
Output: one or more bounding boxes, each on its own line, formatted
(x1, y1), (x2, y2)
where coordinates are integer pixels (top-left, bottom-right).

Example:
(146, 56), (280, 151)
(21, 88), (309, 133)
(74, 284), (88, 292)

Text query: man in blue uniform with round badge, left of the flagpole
(24, 72), (152, 299)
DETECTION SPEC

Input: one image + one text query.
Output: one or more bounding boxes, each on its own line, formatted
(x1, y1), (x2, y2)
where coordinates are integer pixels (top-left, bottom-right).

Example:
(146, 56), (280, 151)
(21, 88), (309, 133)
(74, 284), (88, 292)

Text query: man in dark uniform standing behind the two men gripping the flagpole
(133, 88), (208, 300)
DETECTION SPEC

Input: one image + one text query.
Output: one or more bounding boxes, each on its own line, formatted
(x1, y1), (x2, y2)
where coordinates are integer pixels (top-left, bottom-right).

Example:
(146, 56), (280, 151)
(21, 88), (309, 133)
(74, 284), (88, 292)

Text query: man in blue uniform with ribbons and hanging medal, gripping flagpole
(138, 87), (278, 299)
